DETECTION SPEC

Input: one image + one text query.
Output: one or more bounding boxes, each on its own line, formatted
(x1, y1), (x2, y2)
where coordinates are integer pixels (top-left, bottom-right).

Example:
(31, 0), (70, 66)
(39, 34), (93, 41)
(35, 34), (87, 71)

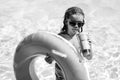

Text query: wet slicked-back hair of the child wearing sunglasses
(61, 7), (85, 33)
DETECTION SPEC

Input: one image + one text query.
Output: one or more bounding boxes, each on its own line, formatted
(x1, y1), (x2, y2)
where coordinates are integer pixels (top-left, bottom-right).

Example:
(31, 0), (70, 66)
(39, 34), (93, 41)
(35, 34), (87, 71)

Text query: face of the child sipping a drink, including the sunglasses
(67, 14), (84, 36)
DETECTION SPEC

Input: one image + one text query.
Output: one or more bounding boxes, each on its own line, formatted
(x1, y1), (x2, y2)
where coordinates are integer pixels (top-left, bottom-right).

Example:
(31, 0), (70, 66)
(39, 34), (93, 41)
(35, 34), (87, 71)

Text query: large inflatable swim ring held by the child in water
(13, 31), (89, 80)
